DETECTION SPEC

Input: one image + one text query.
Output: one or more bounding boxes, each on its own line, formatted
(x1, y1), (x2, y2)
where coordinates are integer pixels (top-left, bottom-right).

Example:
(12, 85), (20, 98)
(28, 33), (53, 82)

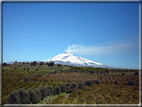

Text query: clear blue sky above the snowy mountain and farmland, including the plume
(3, 3), (139, 69)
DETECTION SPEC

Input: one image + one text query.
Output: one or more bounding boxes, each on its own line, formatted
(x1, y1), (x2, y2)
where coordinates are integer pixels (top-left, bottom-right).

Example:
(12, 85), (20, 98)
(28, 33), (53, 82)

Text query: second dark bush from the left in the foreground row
(18, 89), (30, 104)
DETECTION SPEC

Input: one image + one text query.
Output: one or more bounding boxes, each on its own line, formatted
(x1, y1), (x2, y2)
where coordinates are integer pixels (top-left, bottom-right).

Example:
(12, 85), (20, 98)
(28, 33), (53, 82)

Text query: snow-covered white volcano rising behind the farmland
(43, 53), (109, 68)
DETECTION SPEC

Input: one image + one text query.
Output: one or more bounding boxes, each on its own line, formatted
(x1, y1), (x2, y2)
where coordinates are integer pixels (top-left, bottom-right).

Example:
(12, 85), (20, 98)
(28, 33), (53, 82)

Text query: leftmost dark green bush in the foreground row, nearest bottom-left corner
(6, 90), (20, 104)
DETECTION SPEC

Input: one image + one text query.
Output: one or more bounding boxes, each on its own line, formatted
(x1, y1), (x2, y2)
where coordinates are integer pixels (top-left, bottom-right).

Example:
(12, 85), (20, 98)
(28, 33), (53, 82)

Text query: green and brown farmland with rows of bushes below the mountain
(2, 62), (139, 104)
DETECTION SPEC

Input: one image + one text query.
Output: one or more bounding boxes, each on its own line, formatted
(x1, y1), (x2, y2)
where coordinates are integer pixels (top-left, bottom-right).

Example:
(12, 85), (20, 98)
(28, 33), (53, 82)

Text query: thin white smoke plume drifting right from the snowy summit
(65, 43), (139, 55)
